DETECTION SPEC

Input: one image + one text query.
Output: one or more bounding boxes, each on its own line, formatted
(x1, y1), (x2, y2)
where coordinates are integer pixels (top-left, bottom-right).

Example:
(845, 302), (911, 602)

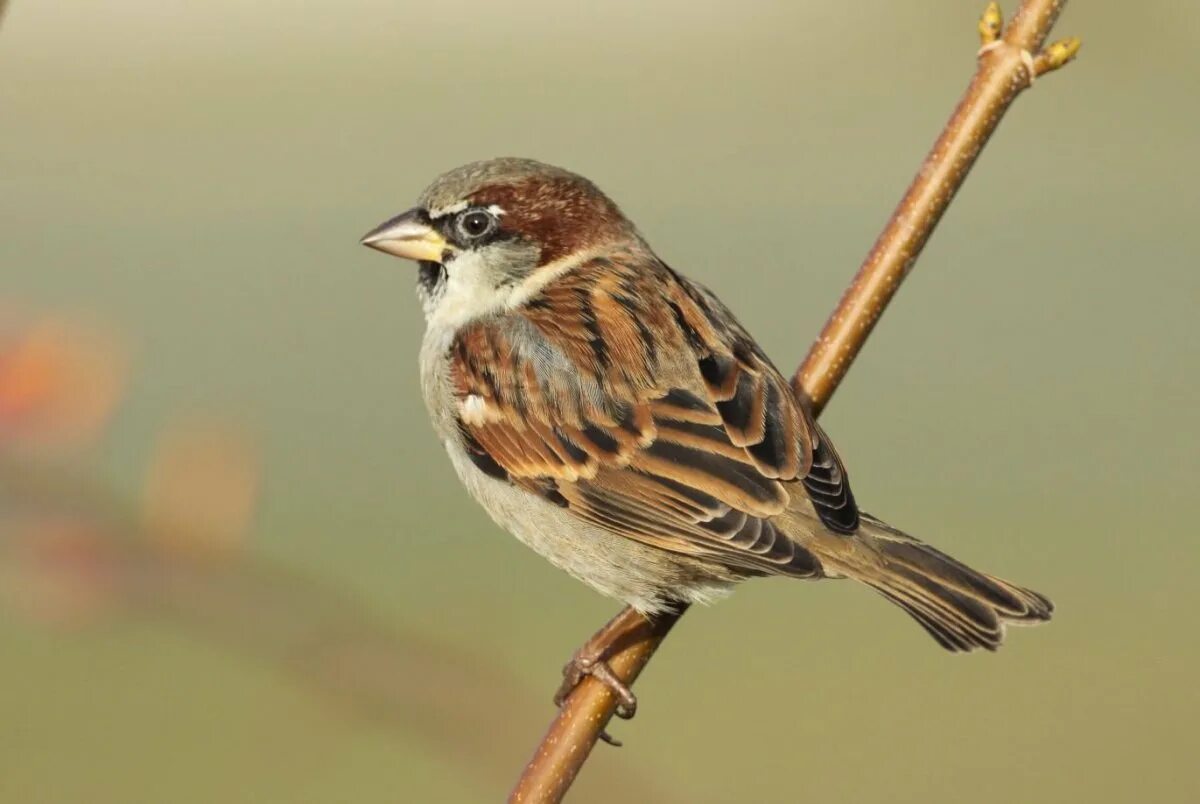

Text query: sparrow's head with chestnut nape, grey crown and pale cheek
(362, 158), (637, 320)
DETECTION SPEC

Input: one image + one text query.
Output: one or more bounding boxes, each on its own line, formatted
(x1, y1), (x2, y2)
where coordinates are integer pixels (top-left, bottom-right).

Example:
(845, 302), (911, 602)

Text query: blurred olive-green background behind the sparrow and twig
(0, 0), (1200, 804)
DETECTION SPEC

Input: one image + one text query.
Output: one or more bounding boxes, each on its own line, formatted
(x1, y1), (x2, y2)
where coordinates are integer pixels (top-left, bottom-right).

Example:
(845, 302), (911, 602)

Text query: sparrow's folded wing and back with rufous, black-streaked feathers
(450, 254), (857, 575)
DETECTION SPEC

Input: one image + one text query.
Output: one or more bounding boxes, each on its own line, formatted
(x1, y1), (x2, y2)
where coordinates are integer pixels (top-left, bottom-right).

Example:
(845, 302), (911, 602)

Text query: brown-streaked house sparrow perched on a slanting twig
(362, 158), (1052, 714)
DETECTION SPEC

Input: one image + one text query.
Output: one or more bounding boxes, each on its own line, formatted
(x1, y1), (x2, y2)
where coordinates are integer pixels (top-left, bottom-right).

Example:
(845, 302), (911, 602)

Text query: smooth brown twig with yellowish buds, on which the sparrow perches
(509, 0), (1079, 804)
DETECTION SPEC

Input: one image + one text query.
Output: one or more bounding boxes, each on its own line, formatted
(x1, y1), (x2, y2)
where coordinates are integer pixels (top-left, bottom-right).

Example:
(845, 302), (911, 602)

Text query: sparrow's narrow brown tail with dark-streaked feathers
(847, 515), (1054, 650)
